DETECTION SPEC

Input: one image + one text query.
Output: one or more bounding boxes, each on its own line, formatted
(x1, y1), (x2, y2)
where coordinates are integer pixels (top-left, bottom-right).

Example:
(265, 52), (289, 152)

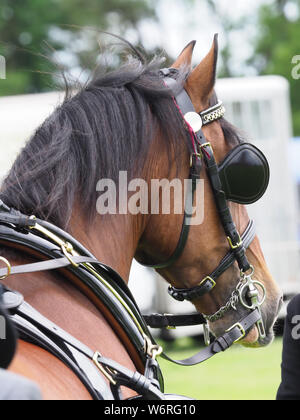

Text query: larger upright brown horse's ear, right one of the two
(186, 34), (218, 112)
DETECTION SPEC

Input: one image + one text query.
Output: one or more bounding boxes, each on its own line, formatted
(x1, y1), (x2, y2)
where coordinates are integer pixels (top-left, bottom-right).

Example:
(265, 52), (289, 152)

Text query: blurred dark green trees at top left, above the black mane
(0, 0), (156, 95)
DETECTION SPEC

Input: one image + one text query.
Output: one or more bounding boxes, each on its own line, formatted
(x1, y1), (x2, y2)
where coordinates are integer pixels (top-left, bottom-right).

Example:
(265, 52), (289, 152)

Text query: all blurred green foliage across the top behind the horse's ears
(0, 0), (300, 136)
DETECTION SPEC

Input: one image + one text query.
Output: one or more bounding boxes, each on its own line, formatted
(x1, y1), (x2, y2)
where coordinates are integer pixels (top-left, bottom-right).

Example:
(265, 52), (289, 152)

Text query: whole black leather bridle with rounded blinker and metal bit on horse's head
(142, 69), (269, 339)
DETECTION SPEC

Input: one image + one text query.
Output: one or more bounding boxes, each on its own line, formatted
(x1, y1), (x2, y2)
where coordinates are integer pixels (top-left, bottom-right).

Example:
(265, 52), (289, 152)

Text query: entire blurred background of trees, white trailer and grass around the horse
(0, 0), (300, 399)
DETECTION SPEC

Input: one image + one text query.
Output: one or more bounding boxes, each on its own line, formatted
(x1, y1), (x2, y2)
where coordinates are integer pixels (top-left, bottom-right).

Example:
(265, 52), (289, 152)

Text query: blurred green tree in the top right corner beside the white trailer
(249, 0), (300, 136)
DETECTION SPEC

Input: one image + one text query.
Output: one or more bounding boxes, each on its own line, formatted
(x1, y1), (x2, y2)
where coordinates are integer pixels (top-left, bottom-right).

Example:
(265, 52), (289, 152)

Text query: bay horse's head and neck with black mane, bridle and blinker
(0, 38), (281, 398)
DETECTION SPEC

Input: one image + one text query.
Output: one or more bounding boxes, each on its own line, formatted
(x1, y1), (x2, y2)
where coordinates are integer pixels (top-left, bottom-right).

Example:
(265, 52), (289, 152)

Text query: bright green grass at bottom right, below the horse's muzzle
(159, 338), (282, 400)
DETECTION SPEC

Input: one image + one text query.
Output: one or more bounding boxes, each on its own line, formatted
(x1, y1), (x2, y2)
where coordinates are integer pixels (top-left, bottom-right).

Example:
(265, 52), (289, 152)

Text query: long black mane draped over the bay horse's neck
(0, 46), (243, 229)
